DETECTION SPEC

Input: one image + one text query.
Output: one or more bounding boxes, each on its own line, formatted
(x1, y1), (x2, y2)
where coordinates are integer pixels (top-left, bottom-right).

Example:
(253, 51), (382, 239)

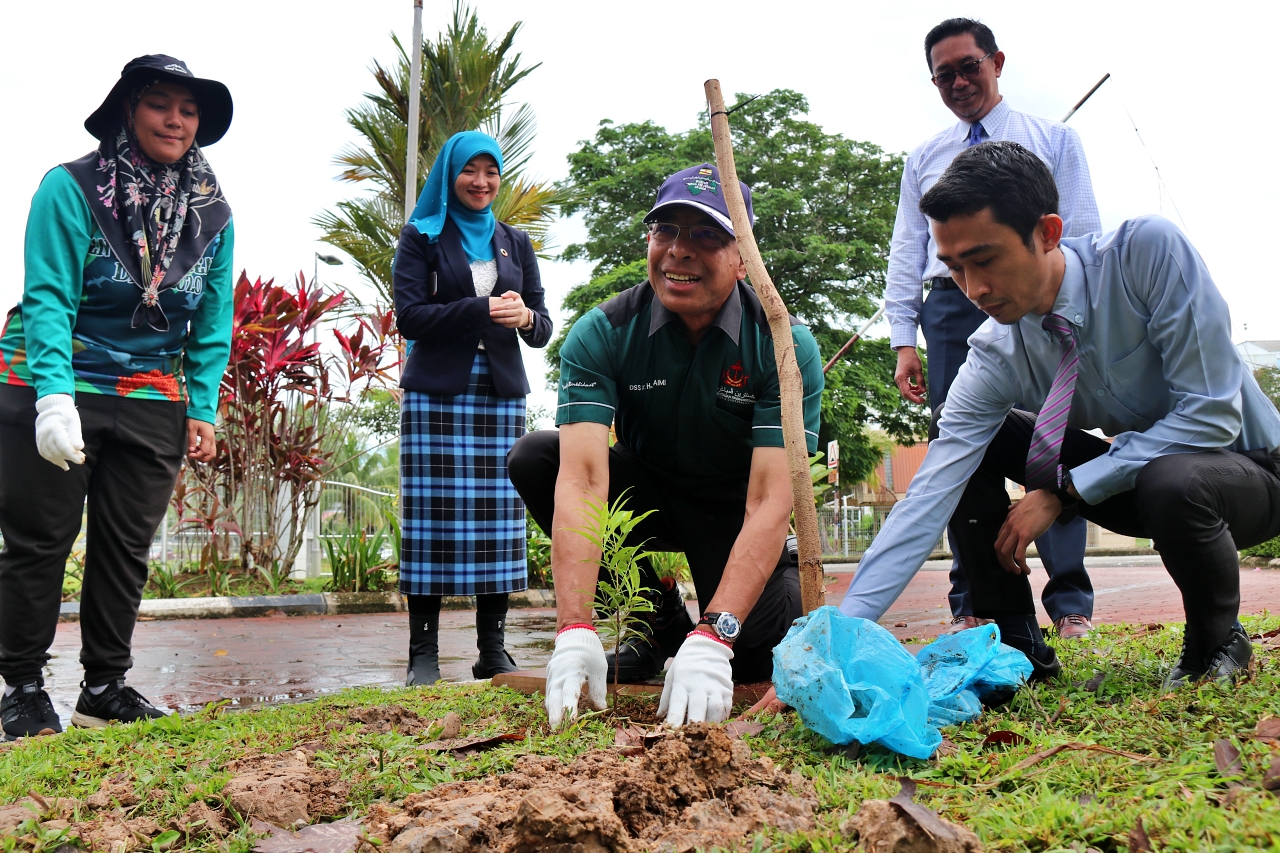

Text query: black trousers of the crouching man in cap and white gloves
(507, 429), (801, 684)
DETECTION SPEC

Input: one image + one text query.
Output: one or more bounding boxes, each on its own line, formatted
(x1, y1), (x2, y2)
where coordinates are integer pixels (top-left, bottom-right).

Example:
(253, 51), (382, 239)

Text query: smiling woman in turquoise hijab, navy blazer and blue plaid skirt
(393, 131), (552, 685)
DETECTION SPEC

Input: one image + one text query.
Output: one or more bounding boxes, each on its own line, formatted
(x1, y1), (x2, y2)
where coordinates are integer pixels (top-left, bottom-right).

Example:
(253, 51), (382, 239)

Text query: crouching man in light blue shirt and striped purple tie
(840, 142), (1280, 689)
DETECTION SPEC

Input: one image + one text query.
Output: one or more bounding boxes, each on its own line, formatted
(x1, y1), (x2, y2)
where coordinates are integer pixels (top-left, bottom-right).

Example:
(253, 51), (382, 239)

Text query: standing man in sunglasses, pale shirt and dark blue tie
(884, 18), (1102, 639)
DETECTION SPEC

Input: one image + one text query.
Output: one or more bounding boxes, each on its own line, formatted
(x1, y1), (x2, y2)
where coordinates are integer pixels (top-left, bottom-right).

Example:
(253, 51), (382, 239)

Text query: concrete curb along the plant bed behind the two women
(58, 589), (556, 622)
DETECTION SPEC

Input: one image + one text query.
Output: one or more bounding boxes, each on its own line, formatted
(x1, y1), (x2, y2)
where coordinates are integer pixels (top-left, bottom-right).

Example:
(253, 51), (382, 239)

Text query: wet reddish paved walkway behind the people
(46, 557), (1280, 722)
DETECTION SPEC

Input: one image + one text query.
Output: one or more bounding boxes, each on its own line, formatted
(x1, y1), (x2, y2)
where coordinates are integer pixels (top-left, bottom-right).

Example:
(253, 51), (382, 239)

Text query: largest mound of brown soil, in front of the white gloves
(365, 724), (817, 853)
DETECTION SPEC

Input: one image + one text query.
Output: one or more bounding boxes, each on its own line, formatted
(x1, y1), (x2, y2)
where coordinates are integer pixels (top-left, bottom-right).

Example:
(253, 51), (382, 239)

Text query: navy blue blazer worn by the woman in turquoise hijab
(392, 219), (552, 397)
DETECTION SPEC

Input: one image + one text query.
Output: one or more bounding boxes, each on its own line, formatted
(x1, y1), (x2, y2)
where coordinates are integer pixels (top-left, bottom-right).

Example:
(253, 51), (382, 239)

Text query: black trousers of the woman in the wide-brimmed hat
(0, 386), (187, 685)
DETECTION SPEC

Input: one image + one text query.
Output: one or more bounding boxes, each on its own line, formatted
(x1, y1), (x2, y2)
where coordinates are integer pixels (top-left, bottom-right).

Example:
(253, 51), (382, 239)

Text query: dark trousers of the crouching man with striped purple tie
(951, 410), (1280, 665)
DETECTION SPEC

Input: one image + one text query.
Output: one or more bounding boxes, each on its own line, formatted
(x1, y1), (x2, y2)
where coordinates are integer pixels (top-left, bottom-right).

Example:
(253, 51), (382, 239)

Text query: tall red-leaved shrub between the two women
(174, 273), (398, 580)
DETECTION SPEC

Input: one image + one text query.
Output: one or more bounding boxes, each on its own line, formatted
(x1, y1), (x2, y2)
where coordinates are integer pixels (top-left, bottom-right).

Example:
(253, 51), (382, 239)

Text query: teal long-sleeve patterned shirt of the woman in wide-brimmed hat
(0, 167), (234, 423)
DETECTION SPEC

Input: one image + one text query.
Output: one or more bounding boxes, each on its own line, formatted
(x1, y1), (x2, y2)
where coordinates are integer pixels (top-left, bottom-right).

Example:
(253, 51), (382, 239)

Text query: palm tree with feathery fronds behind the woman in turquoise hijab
(315, 0), (568, 302)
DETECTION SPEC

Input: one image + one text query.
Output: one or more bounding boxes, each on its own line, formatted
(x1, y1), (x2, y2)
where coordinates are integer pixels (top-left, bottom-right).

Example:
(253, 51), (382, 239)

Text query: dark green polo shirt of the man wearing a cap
(556, 282), (823, 479)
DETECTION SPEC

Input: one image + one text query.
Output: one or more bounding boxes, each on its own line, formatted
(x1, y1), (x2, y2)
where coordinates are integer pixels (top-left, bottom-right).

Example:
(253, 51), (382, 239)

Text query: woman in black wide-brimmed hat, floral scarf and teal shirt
(0, 55), (233, 740)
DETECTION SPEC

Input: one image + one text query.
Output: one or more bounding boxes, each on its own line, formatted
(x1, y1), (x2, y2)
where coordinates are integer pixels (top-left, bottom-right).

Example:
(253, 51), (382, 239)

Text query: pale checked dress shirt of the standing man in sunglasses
(884, 100), (1102, 347)
